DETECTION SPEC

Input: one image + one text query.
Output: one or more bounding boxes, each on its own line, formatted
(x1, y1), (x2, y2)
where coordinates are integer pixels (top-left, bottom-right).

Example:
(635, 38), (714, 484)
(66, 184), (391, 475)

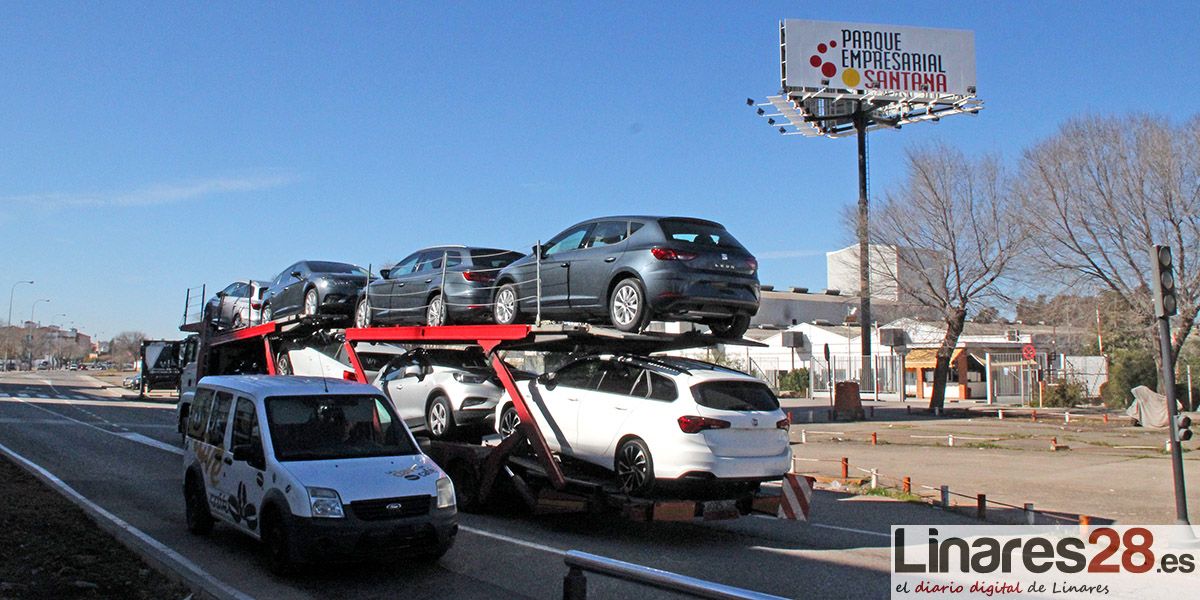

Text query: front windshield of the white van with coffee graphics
(266, 395), (418, 461)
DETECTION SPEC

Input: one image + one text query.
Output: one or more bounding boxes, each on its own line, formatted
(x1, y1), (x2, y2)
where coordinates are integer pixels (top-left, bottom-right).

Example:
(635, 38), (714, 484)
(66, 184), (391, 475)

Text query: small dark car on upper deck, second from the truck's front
(263, 260), (368, 322)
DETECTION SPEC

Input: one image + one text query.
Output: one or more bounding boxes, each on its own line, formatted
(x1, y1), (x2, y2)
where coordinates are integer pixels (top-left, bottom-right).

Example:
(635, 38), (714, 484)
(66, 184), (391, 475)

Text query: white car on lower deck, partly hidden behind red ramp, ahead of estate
(374, 347), (533, 439)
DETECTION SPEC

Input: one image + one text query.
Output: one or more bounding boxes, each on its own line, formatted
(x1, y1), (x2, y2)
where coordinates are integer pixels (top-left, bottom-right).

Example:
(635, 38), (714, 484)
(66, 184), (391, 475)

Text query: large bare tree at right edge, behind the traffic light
(1019, 115), (1200, 381)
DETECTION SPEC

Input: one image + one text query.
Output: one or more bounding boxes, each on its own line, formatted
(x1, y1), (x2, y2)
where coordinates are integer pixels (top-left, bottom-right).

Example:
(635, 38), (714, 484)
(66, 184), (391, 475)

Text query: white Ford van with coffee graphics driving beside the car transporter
(184, 376), (458, 572)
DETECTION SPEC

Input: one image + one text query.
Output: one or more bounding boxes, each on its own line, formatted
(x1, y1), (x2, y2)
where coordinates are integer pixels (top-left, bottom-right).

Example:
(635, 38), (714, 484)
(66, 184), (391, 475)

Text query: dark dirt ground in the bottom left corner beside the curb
(0, 457), (190, 599)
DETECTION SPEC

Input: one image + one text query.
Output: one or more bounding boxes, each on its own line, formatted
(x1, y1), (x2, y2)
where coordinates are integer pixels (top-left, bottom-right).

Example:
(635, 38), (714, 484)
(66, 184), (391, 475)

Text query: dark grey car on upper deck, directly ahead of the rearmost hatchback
(354, 246), (521, 328)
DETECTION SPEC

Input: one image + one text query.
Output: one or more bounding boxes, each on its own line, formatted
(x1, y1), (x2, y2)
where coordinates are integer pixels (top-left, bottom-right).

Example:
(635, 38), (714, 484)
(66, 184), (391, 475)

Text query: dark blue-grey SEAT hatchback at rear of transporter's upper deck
(493, 216), (758, 338)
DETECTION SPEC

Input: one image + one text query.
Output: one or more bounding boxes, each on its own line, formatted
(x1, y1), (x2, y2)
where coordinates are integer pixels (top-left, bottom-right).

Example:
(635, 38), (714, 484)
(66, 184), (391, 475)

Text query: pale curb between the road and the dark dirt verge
(0, 444), (253, 600)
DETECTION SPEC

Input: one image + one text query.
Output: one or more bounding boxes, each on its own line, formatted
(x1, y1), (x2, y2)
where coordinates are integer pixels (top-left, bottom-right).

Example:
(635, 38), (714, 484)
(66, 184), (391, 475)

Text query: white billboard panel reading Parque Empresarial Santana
(780, 19), (976, 97)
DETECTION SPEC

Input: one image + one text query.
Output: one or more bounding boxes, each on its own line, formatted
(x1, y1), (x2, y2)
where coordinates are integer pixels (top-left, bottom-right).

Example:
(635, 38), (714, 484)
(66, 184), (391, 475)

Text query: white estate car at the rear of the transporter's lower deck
(496, 354), (792, 494)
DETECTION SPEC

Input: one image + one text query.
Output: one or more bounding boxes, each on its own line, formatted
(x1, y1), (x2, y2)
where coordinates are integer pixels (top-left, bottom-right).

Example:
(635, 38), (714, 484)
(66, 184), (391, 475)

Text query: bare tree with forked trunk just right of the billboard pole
(871, 144), (1025, 410)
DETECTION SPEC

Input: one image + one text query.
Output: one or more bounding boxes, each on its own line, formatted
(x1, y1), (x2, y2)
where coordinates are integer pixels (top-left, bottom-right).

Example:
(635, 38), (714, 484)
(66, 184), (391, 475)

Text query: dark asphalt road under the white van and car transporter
(0, 372), (976, 599)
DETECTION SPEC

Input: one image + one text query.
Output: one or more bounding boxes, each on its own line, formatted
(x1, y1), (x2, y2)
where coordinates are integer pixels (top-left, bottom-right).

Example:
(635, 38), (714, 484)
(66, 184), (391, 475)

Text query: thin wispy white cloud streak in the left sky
(0, 175), (296, 208)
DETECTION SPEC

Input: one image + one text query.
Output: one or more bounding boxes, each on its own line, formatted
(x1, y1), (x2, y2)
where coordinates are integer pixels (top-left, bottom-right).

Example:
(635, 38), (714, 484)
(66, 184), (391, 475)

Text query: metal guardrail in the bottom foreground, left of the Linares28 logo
(563, 550), (785, 600)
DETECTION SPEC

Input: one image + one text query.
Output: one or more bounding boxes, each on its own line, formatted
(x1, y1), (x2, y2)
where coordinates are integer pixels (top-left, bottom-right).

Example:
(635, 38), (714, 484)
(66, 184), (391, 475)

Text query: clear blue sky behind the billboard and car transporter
(0, 0), (1200, 338)
